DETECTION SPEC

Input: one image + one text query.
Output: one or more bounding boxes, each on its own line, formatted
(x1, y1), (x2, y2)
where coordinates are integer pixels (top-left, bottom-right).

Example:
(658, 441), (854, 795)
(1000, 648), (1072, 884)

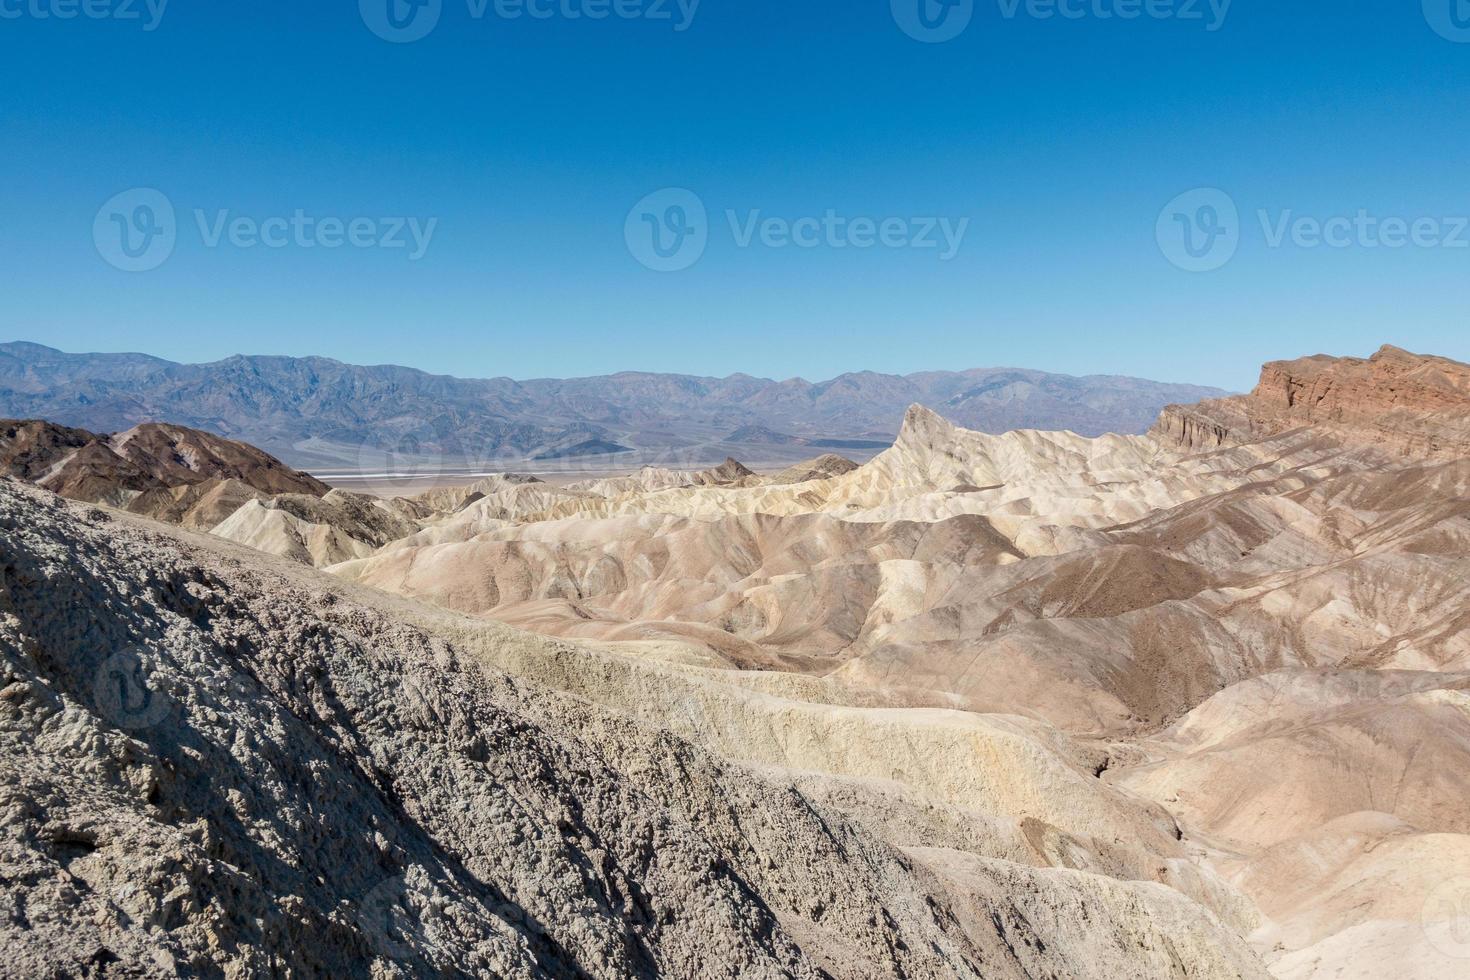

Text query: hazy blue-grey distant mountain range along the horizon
(0, 342), (1227, 472)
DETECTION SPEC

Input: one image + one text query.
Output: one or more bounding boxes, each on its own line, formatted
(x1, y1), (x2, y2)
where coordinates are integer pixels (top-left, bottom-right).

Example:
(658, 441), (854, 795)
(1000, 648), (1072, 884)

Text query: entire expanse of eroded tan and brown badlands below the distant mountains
(0, 347), (1470, 980)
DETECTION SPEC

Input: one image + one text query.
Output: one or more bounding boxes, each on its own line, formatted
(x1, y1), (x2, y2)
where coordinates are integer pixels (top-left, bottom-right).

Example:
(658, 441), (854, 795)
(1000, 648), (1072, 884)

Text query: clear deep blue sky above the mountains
(0, 0), (1470, 389)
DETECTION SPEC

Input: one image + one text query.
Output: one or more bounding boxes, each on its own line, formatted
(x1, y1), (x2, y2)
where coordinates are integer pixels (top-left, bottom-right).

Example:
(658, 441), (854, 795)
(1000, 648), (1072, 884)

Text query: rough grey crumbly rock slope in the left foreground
(0, 480), (1266, 979)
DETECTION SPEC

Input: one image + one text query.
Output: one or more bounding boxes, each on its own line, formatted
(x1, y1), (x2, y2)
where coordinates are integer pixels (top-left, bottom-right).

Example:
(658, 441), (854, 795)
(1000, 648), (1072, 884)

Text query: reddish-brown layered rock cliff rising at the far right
(1154, 347), (1470, 460)
